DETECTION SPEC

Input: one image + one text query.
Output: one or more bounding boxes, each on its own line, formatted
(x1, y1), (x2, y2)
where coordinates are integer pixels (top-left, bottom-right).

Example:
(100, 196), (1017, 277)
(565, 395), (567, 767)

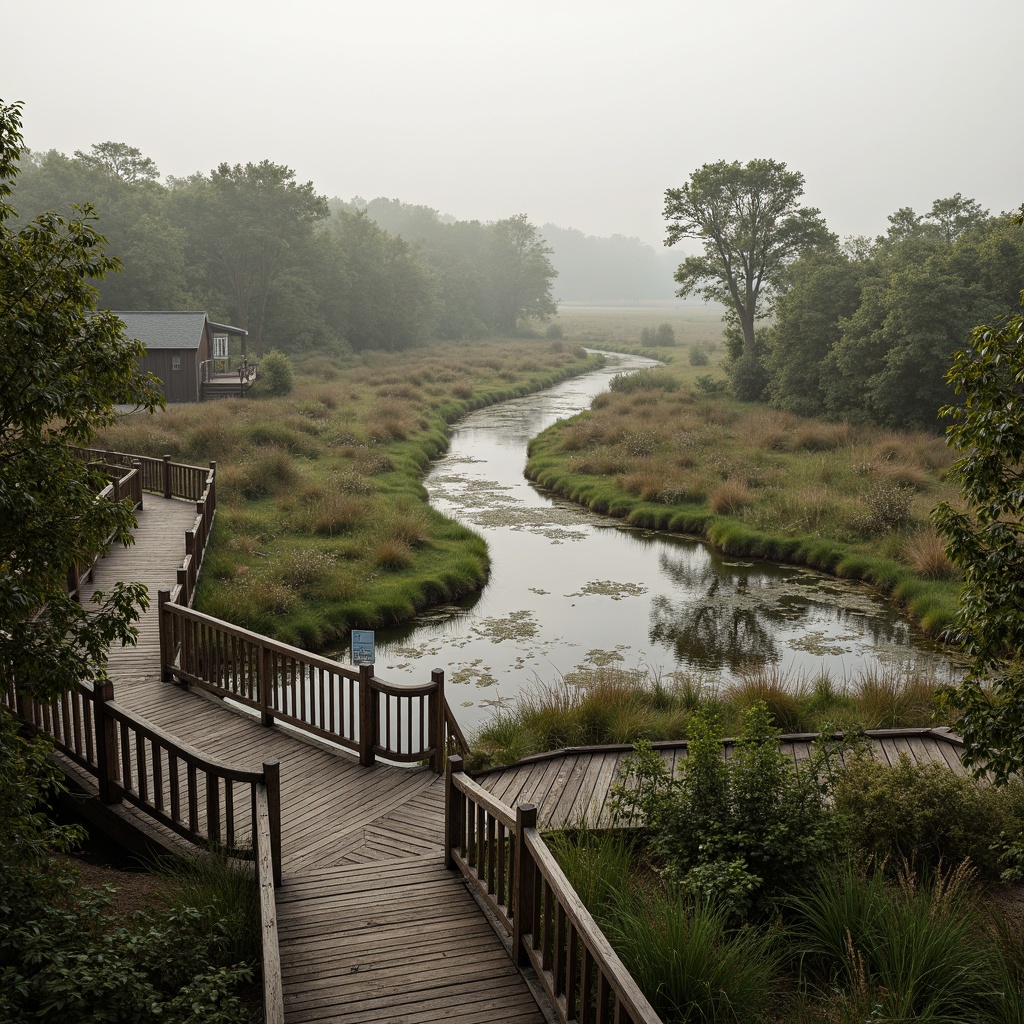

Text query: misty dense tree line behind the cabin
(8, 142), (556, 352)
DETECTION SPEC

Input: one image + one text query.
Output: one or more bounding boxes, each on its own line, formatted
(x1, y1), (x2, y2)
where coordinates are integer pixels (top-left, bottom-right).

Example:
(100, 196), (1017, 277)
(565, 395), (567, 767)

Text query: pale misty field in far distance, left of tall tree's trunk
(555, 300), (722, 348)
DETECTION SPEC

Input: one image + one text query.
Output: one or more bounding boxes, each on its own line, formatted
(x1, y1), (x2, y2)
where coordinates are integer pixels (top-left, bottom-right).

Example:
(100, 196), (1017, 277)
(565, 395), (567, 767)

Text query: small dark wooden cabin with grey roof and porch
(114, 309), (257, 402)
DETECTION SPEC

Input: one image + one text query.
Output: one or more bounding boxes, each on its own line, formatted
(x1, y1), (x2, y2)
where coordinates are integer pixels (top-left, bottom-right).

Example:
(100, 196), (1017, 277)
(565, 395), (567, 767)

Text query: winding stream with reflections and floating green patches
(354, 356), (953, 729)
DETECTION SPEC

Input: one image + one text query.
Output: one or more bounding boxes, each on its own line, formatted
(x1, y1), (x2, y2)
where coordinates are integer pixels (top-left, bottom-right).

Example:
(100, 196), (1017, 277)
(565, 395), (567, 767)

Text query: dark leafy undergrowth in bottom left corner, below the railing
(0, 709), (259, 1024)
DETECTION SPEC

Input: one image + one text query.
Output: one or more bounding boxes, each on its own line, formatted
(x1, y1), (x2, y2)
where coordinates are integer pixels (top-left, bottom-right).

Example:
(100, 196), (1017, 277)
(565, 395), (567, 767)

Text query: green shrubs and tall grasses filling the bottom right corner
(548, 707), (1024, 1024)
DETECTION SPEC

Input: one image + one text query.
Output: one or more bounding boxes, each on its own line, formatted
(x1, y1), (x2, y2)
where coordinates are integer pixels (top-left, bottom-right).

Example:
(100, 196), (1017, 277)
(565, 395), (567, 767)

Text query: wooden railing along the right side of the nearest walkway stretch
(444, 756), (662, 1024)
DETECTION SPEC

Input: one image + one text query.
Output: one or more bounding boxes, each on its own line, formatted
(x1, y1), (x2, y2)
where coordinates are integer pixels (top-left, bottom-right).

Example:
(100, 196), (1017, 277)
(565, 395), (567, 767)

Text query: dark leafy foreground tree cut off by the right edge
(932, 206), (1024, 782)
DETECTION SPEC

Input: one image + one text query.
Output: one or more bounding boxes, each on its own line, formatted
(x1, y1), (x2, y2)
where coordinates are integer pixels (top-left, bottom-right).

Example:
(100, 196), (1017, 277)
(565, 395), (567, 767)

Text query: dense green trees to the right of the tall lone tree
(758, 194), (1024, 430)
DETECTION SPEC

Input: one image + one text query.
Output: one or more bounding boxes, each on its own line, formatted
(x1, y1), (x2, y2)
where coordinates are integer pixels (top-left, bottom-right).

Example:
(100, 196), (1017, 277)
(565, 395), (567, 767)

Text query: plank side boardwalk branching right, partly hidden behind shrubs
(476, 729), (967, 828)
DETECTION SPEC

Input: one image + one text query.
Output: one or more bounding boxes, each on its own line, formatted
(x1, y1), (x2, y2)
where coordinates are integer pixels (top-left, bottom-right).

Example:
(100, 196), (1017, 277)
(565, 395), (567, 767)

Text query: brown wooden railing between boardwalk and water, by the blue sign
(158, 591), (465, 772)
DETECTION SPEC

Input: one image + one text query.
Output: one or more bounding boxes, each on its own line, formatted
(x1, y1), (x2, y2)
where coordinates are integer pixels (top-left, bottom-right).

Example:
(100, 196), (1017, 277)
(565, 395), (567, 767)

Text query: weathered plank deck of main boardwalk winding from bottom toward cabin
(82, 494), (546, 1024)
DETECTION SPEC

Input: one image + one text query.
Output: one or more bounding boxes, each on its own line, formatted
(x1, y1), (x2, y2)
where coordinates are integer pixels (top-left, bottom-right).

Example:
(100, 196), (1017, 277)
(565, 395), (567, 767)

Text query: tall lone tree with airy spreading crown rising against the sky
(665, 160), (836, 357)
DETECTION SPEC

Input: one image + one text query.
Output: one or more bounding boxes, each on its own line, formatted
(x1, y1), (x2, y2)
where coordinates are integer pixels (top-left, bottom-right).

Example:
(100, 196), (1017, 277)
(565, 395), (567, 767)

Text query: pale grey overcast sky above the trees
(0, 0), (1024, 245)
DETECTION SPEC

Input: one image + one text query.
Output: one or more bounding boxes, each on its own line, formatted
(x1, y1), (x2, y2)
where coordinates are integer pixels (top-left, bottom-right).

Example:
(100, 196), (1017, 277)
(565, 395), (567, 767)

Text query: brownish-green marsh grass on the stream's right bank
(526, 362), (957, 634)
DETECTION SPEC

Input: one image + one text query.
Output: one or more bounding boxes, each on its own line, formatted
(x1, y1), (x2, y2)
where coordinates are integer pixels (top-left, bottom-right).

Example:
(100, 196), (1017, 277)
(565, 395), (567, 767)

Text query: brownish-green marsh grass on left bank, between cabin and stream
(96, 339), (600, 649)
